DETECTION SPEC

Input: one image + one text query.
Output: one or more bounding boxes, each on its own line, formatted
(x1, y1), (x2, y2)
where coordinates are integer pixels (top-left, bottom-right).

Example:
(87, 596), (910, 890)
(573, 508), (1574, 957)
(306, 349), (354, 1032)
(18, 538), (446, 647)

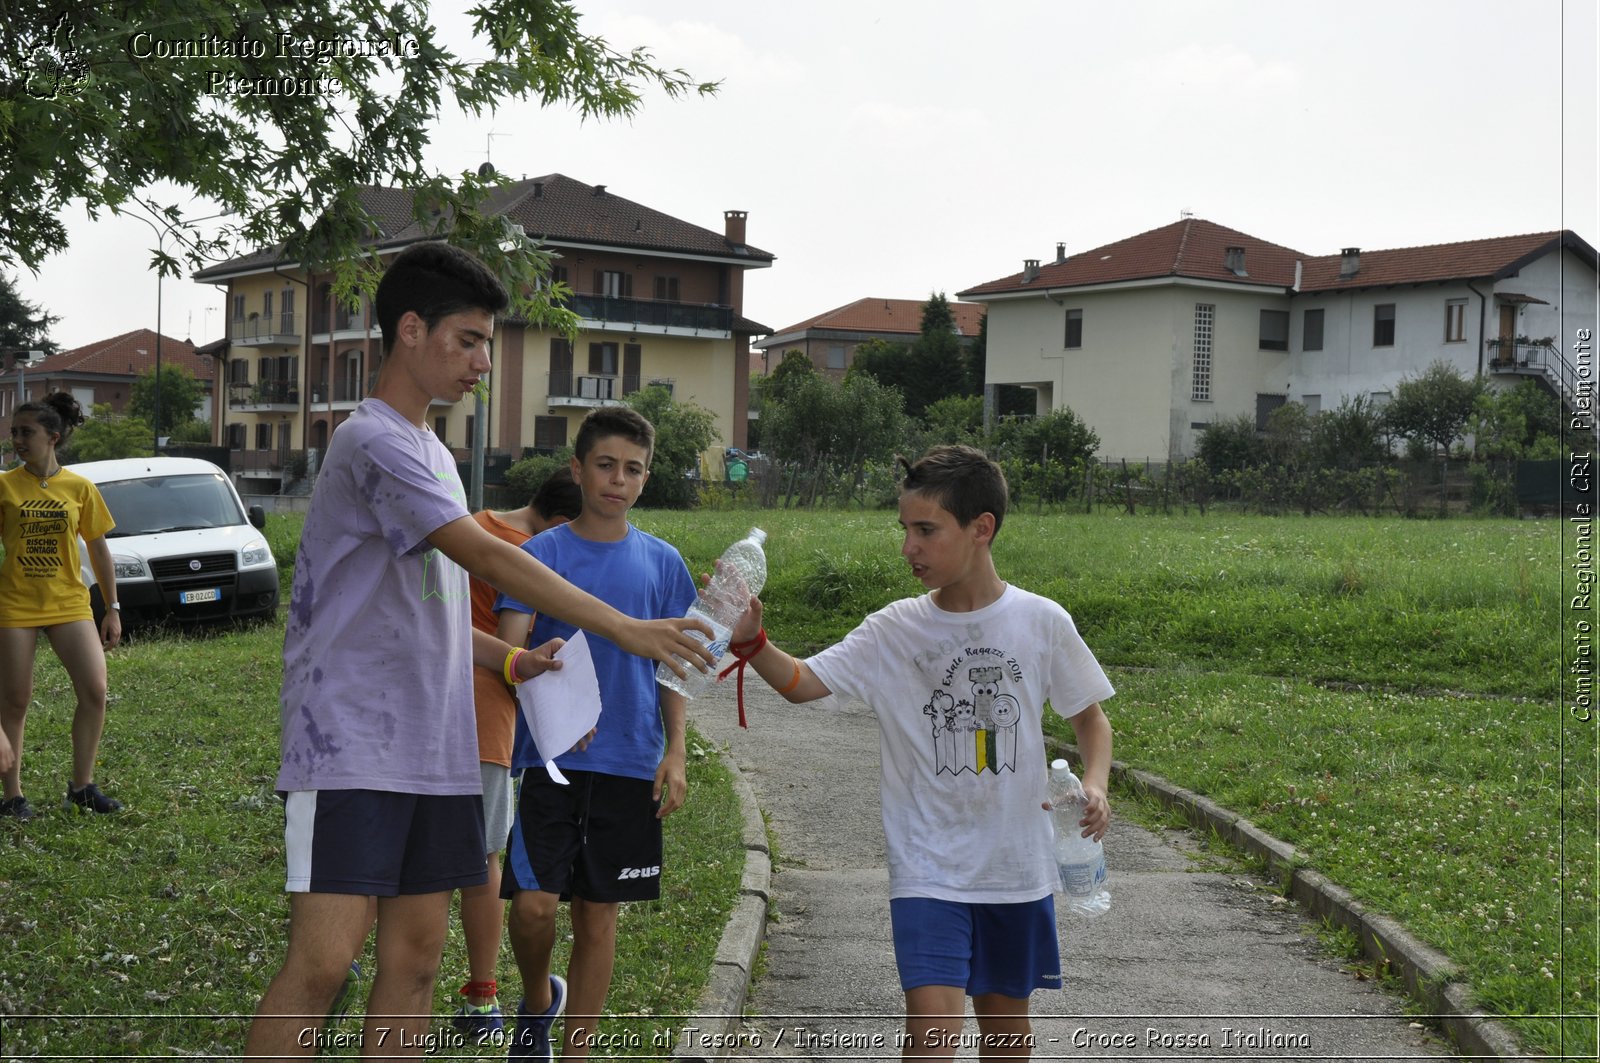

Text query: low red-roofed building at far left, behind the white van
(0, 328), (214, 421)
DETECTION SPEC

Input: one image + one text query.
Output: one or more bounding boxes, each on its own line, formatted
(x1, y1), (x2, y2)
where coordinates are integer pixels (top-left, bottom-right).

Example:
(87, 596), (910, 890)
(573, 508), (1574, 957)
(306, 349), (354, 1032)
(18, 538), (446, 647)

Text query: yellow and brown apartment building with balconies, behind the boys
(195, 173), (773, 490)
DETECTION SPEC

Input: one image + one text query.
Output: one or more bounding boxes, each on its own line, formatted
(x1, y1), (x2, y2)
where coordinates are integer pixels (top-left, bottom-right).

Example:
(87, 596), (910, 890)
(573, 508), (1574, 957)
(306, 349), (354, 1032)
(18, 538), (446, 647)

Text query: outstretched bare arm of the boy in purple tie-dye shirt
(427, 517), (714, 676)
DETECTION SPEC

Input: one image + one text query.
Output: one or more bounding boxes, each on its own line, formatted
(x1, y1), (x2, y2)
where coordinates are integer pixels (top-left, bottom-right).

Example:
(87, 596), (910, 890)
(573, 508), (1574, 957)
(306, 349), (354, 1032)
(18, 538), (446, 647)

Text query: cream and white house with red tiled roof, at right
(958, 218), (1597, 461)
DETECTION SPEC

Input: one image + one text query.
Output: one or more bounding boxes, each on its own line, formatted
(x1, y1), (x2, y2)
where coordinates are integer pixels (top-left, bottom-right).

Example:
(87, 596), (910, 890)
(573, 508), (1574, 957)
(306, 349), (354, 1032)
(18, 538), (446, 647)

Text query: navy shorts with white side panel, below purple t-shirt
(283, 789), (490, 897)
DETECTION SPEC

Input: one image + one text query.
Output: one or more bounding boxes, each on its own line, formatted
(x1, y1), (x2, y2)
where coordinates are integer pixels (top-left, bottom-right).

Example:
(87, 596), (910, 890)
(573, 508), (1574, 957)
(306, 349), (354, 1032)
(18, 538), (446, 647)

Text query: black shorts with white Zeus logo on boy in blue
(501, 768), (661, 903)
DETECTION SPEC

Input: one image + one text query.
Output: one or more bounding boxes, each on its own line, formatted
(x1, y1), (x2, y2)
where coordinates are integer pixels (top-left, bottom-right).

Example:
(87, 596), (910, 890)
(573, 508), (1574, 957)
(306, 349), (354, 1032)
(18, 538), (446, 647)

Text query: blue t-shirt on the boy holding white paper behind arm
(494, 525), (696, 780)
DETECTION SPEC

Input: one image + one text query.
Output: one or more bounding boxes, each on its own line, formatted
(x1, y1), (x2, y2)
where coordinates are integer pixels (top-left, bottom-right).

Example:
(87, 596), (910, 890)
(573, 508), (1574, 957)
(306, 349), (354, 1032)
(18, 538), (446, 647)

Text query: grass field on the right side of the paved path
(643, 512), (1600, 1058)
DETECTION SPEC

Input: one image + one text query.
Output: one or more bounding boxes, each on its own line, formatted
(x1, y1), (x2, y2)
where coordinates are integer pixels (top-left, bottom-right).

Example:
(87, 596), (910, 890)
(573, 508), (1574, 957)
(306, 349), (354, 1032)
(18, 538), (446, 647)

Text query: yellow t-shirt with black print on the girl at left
(0, 466), (117, 628)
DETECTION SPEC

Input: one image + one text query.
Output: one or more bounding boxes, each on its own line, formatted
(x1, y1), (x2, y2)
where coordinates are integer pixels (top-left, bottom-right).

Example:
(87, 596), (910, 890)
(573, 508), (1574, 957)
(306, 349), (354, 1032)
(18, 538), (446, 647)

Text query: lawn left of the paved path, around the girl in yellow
(0, 626), (744, 1060)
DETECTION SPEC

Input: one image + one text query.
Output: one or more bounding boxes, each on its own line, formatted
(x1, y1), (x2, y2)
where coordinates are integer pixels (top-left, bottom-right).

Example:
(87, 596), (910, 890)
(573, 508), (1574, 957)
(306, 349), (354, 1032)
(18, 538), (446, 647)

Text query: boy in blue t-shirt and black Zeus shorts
(494, 407), (696, 1060)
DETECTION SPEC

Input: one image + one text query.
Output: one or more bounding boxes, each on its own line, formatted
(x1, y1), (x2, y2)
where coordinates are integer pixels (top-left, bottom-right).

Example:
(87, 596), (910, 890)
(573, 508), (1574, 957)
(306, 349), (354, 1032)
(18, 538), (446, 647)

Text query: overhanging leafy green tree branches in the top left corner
(0, 0), (715, 328)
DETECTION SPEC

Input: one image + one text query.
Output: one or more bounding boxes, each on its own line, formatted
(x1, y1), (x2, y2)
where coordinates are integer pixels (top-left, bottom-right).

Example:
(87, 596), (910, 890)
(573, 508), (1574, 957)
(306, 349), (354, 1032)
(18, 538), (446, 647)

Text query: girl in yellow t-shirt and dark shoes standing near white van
(0, 391), (122, 820)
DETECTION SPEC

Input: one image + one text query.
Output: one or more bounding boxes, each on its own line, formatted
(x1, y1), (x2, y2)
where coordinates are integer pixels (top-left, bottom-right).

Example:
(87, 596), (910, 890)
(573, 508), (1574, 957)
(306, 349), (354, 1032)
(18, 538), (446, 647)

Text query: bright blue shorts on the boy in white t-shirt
(890, 897), (1061, 999)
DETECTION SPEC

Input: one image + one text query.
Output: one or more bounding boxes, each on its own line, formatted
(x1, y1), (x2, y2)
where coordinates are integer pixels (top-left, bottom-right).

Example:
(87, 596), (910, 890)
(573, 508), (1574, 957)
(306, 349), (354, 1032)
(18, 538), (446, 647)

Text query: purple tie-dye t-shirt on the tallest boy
(278, 399), (482, 794)
